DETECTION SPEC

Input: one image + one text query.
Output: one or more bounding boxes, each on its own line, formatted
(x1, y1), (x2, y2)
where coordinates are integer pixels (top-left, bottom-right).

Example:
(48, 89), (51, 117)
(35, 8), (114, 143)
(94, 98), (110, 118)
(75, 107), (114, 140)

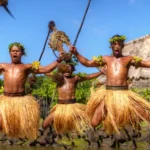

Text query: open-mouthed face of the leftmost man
(10, 46), (23, 63)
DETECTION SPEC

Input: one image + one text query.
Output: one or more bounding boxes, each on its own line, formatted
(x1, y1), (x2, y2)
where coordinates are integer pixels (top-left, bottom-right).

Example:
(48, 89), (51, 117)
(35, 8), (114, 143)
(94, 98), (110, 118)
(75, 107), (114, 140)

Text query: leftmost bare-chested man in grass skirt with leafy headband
(0, 42), (61, 139)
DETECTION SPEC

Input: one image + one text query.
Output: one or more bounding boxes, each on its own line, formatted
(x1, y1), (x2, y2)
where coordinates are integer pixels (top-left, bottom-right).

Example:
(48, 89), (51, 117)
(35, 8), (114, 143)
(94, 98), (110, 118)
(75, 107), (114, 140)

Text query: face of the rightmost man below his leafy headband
(111, 41), (124, 56)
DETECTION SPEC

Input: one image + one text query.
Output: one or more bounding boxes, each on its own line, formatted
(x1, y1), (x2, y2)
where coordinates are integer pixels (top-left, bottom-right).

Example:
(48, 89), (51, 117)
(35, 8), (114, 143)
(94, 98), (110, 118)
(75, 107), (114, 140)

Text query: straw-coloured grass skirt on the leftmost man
(0, 95), (40, 139)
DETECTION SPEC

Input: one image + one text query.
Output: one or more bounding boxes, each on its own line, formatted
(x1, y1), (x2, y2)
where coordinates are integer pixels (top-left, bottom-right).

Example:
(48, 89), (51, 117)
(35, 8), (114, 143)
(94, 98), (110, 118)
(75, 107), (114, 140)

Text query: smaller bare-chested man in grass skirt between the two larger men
(43, 64), (104, 133)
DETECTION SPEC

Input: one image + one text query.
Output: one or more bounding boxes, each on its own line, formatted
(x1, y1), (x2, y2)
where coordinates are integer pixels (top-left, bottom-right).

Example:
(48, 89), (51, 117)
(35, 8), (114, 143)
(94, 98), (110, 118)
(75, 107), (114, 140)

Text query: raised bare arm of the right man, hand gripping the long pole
(70, 46), (99, 67)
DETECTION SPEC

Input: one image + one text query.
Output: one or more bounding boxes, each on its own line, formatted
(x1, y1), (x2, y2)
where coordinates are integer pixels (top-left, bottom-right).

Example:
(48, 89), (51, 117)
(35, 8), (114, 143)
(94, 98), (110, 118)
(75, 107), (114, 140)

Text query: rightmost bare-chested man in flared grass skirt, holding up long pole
(70, 35), (150, 134)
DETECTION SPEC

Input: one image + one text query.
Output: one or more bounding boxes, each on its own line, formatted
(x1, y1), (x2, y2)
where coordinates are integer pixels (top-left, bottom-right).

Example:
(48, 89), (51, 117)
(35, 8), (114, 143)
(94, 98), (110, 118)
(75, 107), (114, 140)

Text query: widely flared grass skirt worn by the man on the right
(86, 88), (150, 134)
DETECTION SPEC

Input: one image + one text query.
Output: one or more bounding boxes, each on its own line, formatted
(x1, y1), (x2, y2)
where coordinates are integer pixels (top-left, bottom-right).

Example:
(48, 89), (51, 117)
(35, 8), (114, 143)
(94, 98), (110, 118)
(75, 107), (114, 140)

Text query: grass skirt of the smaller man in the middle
(50, 103), (91, 134)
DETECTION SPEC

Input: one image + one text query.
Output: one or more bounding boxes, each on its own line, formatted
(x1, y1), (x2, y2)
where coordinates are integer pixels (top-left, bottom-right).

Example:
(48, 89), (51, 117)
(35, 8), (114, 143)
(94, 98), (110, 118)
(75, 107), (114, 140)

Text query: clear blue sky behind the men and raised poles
(0, 0), (150, 73)
